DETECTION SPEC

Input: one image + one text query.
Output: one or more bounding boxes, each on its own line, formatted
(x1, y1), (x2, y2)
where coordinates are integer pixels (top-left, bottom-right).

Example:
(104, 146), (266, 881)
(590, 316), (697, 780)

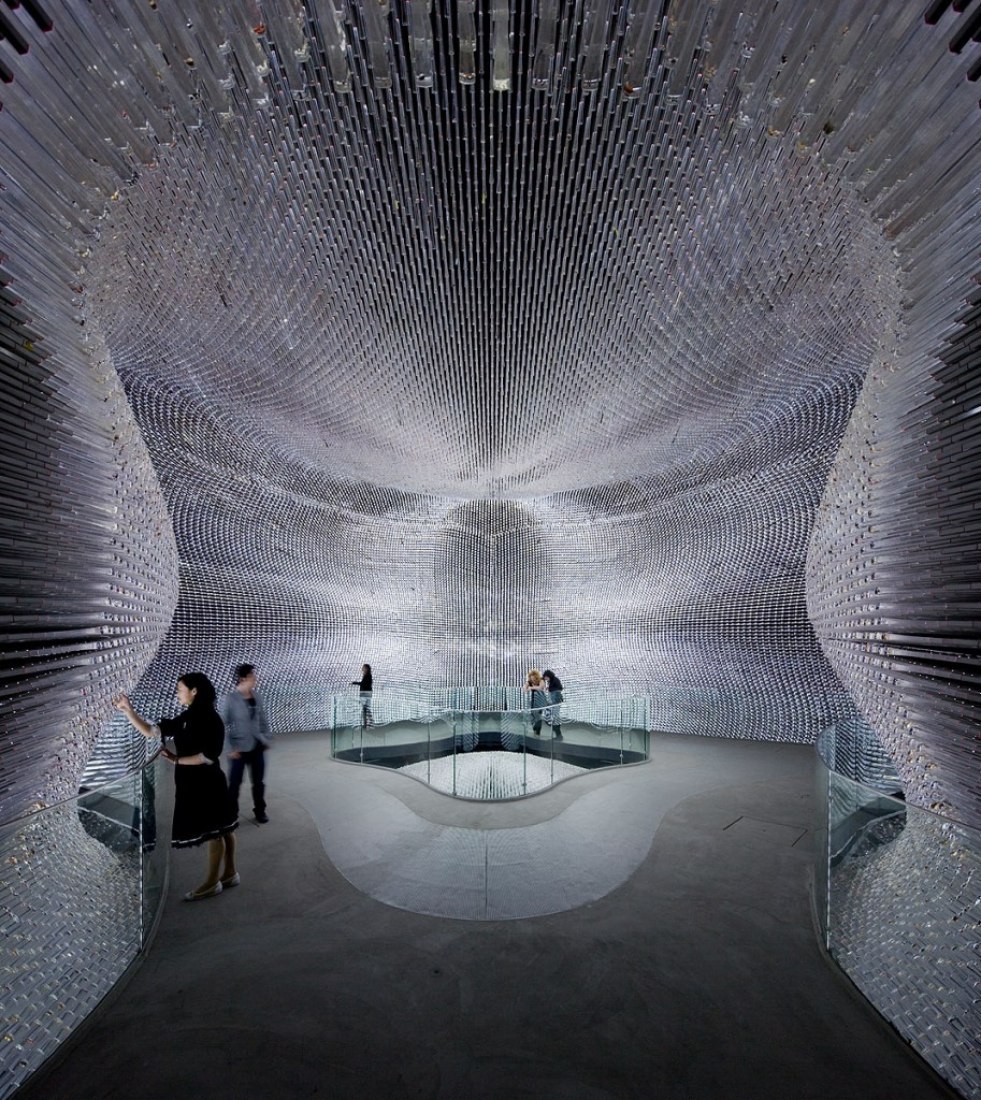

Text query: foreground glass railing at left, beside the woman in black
(0, 761), (170, 1100)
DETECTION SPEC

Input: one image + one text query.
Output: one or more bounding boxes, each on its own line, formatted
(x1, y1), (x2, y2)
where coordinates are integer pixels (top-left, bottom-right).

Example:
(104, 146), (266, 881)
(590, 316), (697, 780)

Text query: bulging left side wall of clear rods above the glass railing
(0, 73), (178, 822)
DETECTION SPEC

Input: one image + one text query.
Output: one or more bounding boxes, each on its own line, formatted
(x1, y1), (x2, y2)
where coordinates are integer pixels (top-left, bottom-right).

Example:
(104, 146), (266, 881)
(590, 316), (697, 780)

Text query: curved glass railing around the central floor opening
(329, 686), (650, 801)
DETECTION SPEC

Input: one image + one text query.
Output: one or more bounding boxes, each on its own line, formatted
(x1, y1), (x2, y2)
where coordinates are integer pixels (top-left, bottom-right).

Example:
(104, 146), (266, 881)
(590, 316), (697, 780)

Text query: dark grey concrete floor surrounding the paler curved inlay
(21, 735), (954, 1100)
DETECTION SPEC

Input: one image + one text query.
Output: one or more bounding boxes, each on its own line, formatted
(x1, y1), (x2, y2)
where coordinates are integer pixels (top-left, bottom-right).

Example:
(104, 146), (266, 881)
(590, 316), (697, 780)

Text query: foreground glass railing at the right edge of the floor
(815, 729), (981, 1097)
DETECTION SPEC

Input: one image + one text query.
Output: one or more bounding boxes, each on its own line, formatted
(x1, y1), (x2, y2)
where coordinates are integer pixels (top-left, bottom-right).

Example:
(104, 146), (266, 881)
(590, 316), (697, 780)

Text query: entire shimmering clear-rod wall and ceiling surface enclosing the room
(0, 0), (981, 1091)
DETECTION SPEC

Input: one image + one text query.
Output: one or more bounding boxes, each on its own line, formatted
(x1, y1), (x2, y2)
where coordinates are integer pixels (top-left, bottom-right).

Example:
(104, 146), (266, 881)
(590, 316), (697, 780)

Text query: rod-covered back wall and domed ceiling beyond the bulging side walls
(72, 8), (899, 738)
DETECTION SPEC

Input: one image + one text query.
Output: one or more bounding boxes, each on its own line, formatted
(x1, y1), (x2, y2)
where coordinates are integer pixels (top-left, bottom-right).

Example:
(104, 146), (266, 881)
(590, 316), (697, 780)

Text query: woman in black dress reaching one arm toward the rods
(112, 672), (239, 901)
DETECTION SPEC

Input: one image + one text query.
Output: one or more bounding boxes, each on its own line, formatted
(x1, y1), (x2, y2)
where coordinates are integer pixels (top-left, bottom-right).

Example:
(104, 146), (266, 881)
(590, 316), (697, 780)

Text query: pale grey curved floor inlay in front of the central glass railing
(279, 737), (809, 921)
